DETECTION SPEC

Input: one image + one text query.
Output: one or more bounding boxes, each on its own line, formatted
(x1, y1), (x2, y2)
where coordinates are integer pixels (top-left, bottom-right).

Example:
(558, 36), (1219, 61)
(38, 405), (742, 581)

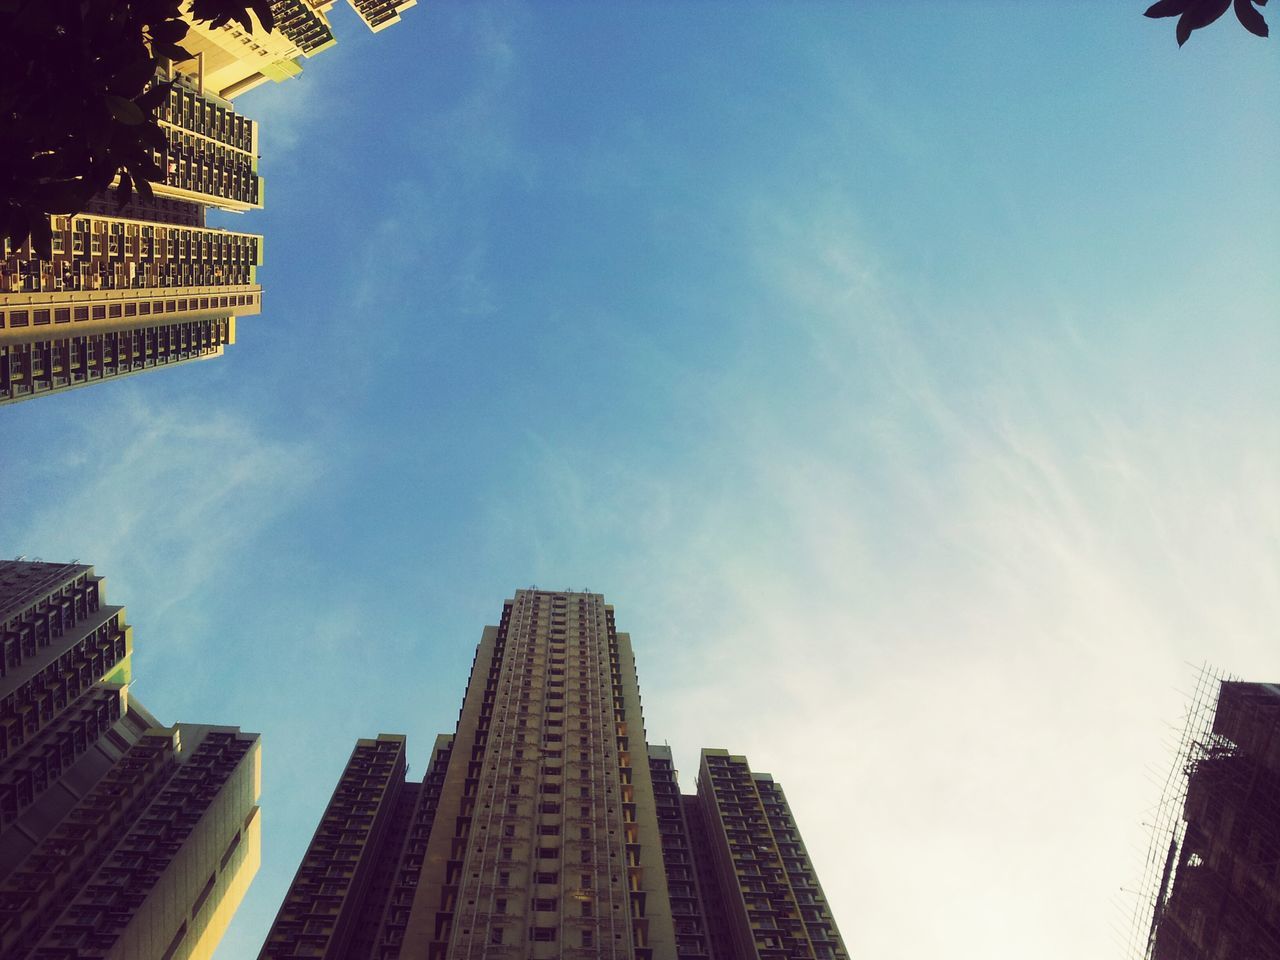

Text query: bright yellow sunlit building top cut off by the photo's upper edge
(182, 0), (417, 100)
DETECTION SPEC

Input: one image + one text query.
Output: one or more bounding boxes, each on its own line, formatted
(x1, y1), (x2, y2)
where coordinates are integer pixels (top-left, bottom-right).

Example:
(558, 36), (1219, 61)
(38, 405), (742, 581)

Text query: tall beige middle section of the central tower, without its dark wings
(401, 590), (676, 960)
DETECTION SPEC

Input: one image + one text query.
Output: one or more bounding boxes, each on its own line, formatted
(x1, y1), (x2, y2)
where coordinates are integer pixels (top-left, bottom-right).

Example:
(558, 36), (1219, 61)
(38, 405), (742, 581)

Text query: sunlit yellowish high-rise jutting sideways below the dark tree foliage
(0, 70), (262, 403)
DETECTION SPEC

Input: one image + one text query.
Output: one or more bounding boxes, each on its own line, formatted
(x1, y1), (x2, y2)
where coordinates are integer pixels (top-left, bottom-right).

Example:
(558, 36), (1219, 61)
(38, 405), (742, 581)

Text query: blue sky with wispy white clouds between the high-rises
(0, 0), (1280, 960)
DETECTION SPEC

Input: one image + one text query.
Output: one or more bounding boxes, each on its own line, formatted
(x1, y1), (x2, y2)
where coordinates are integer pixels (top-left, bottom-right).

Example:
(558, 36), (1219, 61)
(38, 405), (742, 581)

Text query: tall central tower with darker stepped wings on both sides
(260, 590), (847, 960)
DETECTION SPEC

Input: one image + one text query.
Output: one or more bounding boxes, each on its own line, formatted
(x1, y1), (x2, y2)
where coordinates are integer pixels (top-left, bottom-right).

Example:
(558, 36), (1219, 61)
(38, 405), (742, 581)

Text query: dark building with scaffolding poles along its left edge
(1139, 673), (1280, 960)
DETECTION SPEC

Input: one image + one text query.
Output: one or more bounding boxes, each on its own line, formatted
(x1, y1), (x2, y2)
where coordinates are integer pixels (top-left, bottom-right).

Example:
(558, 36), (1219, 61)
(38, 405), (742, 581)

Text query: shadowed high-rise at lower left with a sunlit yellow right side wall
(0, 561), (261, 960)
